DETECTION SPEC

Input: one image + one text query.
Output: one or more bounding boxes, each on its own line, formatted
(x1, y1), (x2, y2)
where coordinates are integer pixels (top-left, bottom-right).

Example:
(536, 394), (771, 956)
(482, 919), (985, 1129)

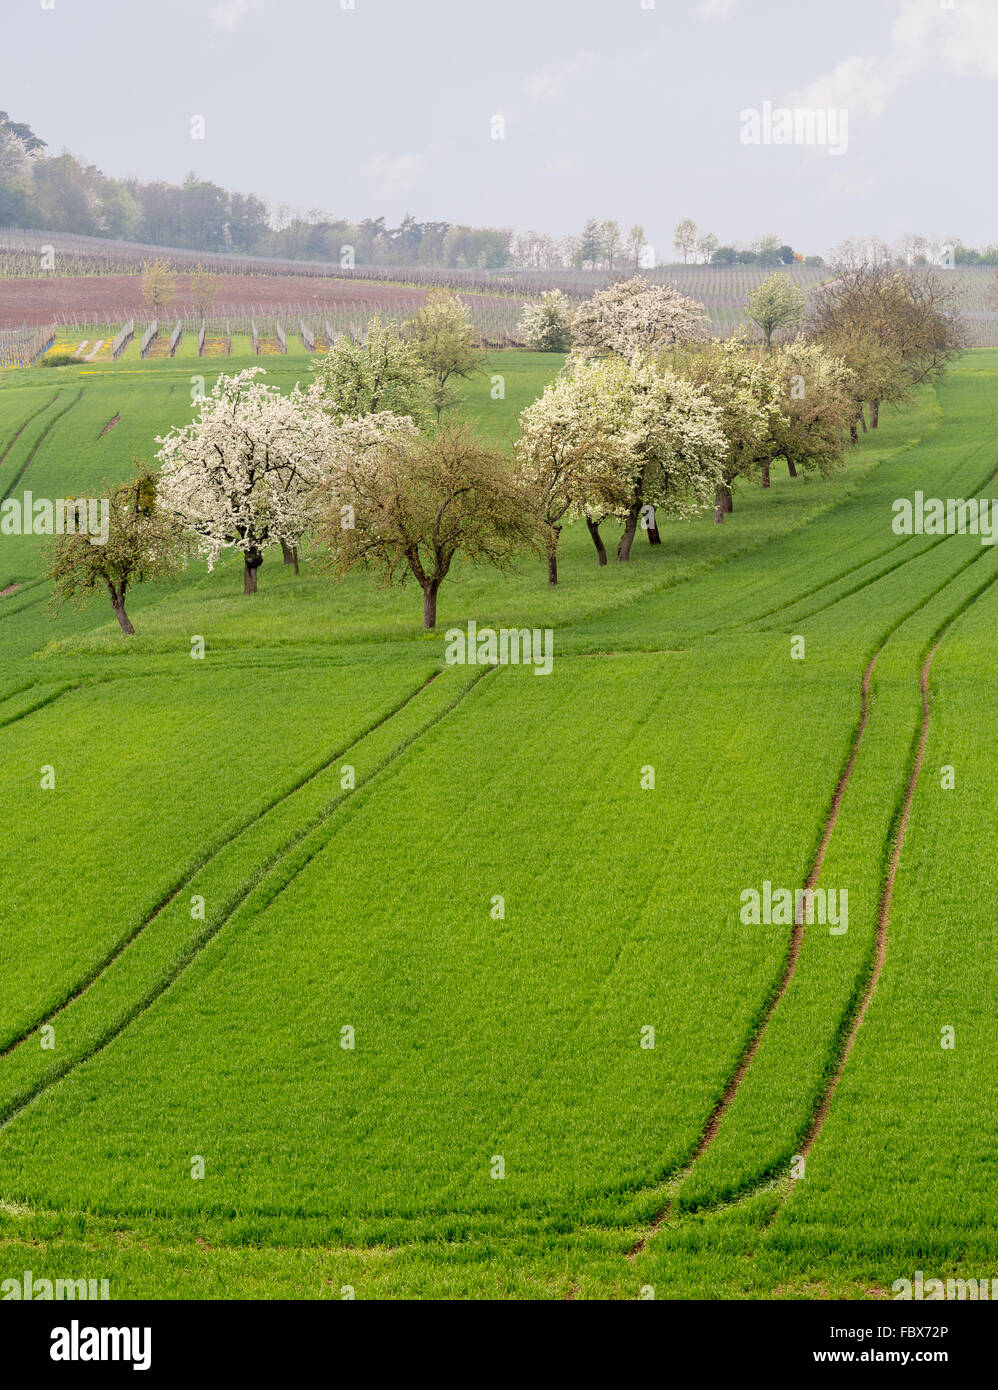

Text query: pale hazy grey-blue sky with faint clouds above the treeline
(0, 0), (998, 259)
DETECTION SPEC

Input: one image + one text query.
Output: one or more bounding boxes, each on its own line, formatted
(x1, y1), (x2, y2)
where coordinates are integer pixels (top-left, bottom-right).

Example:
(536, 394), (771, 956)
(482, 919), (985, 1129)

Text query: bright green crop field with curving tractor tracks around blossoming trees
(0, 343), (998, 1298)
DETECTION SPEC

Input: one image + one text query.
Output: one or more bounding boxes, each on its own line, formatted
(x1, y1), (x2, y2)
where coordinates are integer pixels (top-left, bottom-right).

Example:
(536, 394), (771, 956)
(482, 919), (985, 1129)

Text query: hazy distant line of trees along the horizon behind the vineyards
(0, 111), (998, 282)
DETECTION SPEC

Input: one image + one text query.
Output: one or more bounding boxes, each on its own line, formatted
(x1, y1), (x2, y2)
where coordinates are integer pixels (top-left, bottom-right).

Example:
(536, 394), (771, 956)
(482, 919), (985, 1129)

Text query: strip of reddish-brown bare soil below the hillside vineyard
(0, 274), (517, 328)
